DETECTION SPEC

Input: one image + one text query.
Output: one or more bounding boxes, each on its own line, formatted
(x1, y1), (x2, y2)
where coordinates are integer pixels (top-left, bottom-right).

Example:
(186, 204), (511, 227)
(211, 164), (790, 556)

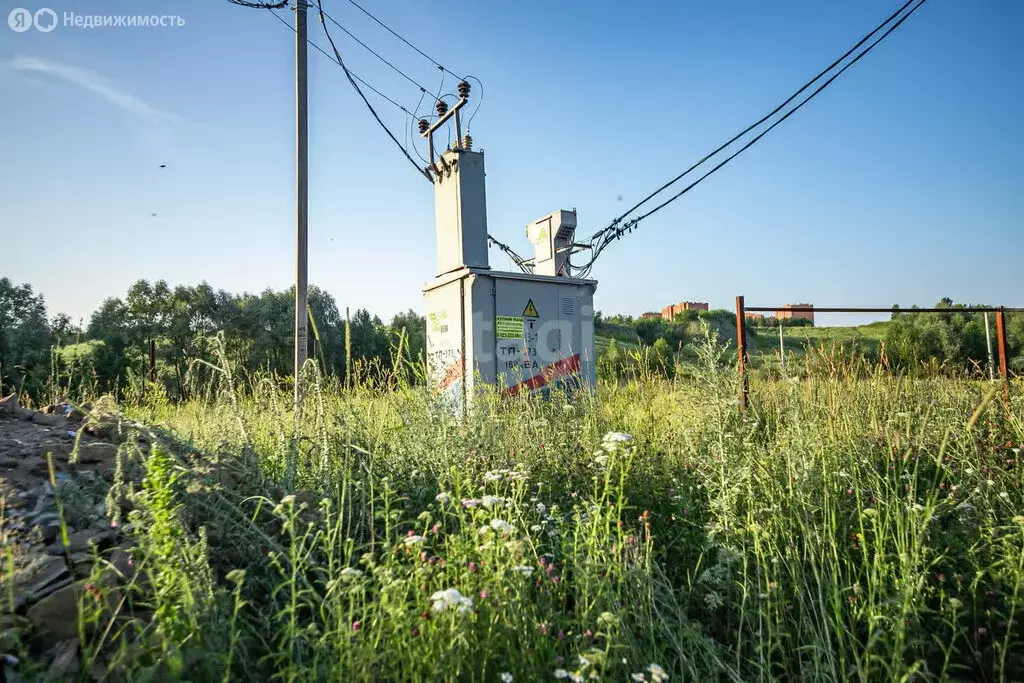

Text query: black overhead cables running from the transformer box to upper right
(579, 0), (927, 276)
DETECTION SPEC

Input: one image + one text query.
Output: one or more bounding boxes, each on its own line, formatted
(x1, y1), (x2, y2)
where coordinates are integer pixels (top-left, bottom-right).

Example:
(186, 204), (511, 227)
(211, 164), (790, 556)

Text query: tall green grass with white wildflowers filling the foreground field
(9, 329), (1024, 681)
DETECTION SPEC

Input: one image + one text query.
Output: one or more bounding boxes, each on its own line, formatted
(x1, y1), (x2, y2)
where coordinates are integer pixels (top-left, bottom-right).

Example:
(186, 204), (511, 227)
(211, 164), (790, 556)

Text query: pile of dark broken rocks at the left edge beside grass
(0, 396), (145, 681)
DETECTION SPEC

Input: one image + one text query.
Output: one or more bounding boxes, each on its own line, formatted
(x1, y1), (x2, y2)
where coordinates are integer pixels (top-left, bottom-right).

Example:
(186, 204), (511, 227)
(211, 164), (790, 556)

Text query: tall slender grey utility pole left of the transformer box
(295, 0), (309, 411)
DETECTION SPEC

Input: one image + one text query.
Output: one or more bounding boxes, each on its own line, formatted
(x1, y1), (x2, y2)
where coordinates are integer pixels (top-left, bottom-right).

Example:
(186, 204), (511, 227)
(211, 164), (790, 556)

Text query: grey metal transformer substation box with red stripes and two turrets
(423, 137), (597, 407)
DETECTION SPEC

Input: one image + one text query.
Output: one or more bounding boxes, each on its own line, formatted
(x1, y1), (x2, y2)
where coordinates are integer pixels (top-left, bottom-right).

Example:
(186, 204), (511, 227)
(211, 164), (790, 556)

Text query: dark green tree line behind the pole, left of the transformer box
(0, 278), (426, 399)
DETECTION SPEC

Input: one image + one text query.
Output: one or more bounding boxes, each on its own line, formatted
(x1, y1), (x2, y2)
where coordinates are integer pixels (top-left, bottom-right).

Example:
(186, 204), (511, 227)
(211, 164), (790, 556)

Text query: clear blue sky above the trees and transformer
(0, 0), (1024, 323)
